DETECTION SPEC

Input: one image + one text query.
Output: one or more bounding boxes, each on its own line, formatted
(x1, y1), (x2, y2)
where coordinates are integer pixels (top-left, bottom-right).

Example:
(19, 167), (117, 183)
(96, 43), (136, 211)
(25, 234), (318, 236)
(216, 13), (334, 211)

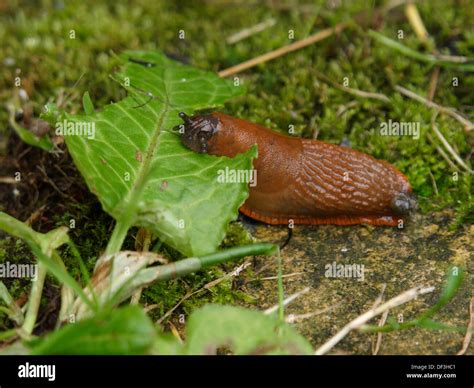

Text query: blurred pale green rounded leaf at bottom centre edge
(186, 305), (313, 354)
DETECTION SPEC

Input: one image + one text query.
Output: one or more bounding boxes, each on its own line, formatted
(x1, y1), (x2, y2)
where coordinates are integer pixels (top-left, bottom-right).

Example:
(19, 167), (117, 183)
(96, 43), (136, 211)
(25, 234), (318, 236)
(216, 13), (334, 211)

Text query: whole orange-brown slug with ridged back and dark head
(180, 112), (415, 226)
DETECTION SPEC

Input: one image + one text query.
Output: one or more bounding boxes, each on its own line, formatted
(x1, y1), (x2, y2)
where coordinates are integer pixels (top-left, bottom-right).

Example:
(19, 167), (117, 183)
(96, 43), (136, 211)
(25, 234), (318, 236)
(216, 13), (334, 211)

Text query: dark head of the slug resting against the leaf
(179, 112), (219, 154)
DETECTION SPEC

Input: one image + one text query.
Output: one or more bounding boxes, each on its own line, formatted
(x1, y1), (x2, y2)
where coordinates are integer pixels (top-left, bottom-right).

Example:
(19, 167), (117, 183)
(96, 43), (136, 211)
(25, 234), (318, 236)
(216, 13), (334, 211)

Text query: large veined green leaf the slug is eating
(63, 51), (252, 256)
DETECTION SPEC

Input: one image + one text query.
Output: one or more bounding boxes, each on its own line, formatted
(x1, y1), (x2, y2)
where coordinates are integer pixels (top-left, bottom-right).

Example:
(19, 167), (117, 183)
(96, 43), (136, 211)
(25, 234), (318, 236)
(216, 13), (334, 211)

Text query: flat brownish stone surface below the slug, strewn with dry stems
(245, 211), (474, 354)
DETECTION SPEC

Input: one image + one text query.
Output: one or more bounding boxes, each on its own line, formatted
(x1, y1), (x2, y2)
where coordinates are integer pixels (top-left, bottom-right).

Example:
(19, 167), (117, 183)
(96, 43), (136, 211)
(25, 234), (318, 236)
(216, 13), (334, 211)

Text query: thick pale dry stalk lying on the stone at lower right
(315, 286), (434, 355)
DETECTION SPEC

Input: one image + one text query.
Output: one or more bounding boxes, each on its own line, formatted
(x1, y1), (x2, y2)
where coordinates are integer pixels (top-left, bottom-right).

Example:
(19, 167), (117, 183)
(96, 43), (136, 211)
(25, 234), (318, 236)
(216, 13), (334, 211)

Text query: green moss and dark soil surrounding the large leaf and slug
(0, 0), (474, 352)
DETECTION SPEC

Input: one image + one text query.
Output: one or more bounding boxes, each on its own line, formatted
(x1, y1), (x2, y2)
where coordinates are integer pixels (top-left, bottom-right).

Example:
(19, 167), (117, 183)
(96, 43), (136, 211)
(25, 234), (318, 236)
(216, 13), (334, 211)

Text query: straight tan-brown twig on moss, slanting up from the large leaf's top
(219, 23), (348, 77)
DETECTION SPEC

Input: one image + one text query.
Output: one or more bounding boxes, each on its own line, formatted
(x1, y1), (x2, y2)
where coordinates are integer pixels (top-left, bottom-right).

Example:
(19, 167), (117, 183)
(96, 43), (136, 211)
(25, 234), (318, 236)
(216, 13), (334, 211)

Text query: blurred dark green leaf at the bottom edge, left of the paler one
(32, 306), (156, 355)
